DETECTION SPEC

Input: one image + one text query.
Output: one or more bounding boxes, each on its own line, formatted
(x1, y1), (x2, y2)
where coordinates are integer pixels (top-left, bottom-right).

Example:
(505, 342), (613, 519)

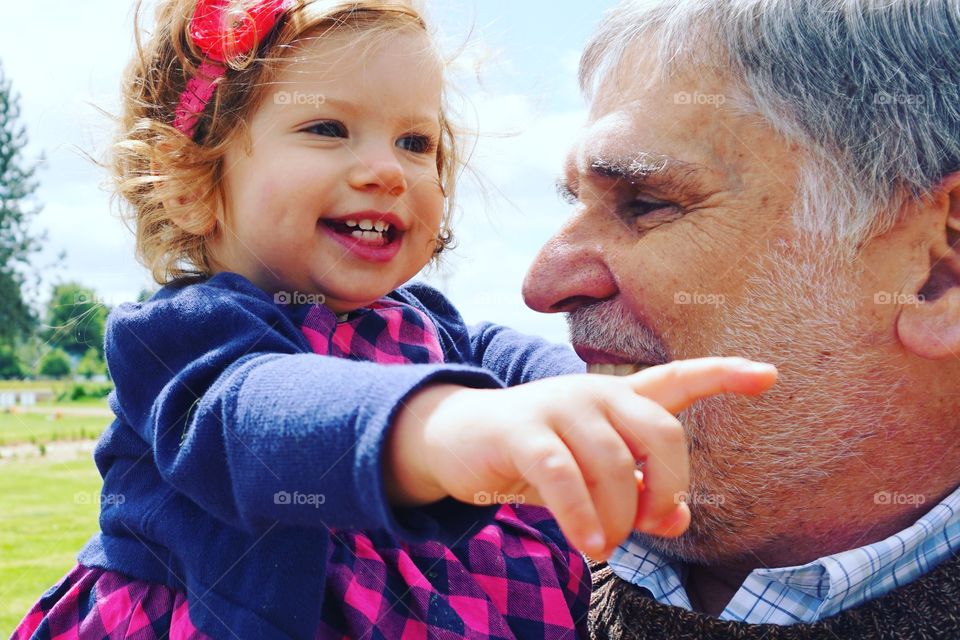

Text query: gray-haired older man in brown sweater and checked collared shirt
(525, 0), (960, 638)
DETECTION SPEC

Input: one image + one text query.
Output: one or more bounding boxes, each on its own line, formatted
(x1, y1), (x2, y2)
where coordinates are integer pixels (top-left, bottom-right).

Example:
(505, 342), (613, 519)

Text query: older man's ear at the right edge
(897, 172), (960, 360)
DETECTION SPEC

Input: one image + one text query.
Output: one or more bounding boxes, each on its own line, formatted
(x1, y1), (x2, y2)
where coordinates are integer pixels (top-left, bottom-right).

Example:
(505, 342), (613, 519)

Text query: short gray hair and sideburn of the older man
(580, 0), (960, 246)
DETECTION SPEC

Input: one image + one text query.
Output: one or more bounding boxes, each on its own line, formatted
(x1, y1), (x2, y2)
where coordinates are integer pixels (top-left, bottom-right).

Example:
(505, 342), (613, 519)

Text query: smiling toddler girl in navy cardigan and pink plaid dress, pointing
(14, 0), (769, 639)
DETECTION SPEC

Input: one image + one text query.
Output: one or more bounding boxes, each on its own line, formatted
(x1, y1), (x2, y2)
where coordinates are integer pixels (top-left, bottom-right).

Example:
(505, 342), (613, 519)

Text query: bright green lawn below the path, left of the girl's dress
(0, 453), (101, 638)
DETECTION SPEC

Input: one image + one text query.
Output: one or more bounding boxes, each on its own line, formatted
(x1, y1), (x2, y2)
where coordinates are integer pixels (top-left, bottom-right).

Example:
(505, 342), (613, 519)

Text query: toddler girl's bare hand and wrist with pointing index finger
(386, 358), (777, 560)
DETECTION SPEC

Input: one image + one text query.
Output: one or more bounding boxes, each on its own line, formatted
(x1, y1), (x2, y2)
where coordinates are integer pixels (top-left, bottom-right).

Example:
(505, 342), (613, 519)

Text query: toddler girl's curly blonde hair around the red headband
(107, 0), (463, 284)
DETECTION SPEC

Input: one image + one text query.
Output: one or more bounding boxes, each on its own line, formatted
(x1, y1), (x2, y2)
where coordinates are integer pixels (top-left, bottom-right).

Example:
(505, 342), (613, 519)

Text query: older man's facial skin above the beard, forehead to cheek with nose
(526, 55), (796, 364)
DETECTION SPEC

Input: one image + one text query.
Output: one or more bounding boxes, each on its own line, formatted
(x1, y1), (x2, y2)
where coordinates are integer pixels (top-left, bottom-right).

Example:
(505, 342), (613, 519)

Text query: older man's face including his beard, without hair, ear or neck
(524, 53), (897, 560)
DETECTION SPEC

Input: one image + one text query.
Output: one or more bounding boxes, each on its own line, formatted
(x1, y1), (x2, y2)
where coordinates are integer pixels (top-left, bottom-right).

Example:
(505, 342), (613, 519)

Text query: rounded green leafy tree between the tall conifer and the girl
(40, 282), (109, 359)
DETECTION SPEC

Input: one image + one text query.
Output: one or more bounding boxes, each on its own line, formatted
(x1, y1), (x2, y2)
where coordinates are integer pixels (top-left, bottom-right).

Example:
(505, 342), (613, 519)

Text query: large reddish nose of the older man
(523, 218), (618, 313)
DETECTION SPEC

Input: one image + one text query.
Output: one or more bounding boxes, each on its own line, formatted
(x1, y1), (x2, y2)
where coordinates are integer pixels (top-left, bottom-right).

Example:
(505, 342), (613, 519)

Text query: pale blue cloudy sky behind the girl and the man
(0, 0), (616, 341)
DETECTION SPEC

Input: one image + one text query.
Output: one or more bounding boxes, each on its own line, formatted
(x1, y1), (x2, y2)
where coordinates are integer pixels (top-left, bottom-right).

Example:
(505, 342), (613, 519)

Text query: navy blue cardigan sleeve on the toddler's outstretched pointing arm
(106, 275), (502, 542)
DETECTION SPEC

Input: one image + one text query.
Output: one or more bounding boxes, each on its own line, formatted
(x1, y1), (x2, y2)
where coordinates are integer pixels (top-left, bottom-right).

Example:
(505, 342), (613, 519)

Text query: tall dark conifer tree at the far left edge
(0, 59), (43, 346)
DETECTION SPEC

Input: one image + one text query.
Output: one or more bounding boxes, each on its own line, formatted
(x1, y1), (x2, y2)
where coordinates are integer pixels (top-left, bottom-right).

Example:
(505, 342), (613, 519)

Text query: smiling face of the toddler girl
(209, 30), (444, 313)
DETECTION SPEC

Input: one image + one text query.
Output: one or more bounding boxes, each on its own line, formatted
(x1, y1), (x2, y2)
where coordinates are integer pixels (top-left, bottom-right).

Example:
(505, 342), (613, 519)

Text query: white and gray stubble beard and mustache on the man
(569, 240), (902, 563)
